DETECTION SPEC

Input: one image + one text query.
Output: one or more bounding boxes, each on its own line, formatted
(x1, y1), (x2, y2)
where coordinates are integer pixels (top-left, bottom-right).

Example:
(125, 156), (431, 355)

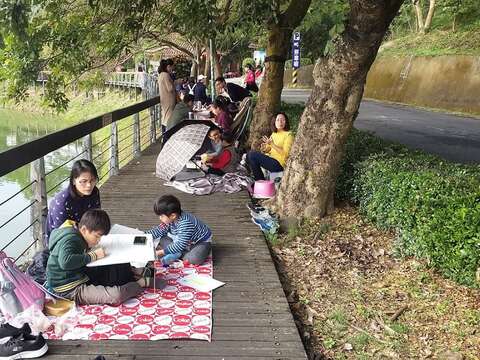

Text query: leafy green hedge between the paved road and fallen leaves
(337, 130), (480, 287)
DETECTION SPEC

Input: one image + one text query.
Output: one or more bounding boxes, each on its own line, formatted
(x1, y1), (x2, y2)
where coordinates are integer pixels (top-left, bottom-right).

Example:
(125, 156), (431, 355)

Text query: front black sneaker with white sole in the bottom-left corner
(0, 333), (48, 360)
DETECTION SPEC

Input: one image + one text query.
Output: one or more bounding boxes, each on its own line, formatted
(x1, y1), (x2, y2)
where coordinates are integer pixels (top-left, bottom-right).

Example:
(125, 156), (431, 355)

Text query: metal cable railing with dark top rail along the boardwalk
(0, 96), (161, 261)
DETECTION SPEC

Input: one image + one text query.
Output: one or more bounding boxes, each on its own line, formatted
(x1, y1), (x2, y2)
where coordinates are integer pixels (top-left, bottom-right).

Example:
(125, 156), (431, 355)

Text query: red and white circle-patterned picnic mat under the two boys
(44, 257), (213, 341)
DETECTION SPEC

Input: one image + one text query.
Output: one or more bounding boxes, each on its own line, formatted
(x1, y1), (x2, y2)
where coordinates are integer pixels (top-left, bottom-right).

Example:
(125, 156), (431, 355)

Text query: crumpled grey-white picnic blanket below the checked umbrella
(164, 173), (254, 195)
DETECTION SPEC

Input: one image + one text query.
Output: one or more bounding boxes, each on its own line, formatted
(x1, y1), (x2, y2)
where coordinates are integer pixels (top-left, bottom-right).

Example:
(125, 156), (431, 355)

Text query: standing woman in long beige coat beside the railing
(158, 59), (176, 133)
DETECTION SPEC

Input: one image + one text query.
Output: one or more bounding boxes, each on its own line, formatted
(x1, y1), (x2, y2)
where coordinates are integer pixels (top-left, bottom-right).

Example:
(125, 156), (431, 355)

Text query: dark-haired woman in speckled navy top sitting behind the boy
(44, 159), (101, 245)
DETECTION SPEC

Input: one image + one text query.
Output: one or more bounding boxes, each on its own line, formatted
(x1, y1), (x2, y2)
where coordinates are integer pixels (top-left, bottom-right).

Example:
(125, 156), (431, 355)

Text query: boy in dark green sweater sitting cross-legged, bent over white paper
(46, 209), (158, 305)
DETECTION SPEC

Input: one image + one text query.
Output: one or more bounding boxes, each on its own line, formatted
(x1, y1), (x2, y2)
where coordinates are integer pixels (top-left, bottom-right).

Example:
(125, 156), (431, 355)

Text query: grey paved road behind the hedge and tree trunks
(282, 89), (480, 164)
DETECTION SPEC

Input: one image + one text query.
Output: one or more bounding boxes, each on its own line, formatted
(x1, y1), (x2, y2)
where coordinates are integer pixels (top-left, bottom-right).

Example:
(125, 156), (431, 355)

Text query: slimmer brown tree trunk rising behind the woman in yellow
(247, 0), (311, 148)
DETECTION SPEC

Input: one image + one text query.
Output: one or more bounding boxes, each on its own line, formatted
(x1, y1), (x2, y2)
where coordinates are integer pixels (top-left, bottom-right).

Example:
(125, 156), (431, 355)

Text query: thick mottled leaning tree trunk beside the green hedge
(275, 0), (403, 217)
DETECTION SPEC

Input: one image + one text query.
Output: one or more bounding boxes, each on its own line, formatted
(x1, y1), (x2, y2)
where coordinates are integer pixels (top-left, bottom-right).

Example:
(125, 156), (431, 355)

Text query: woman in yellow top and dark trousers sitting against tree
(247, 112), (293, 180)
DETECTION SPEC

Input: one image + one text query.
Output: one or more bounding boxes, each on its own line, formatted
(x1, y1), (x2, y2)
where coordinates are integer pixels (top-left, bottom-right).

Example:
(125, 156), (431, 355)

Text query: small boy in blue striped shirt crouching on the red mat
(145, 195), (212, 265)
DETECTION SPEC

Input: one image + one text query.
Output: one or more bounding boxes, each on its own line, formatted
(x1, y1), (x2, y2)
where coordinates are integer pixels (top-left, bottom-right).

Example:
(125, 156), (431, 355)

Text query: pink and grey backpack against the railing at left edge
(0, 251), (45, 318)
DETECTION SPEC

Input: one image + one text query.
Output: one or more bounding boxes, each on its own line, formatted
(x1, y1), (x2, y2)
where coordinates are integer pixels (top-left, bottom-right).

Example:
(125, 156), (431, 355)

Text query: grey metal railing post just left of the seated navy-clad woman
(30, 157), (48, 251)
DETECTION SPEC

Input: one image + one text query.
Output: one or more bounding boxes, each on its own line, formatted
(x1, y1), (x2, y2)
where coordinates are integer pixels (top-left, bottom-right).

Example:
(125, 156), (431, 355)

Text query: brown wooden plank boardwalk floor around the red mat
(47, 145), (307, 360)
